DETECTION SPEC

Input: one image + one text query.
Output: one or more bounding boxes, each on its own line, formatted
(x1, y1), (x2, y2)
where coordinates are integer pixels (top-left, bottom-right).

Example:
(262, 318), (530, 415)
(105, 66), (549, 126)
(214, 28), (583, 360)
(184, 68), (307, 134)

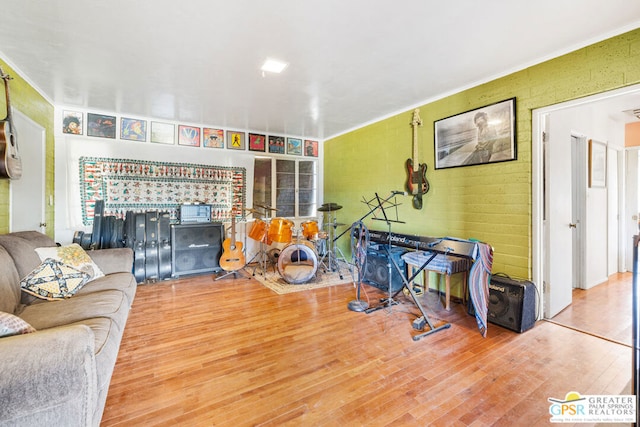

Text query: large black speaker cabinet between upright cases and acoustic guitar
(171, 222), (224, 278)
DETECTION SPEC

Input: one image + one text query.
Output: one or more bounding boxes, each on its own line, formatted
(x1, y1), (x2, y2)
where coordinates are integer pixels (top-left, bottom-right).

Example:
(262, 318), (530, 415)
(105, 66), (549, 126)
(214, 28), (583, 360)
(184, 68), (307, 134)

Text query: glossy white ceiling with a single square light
(0, 0), (640, 139)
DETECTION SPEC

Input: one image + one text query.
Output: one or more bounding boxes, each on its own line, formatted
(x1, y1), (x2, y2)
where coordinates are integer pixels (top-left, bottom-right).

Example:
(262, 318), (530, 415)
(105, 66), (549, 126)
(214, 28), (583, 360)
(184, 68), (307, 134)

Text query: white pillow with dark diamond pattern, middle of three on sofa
(20, 258), (89, 300)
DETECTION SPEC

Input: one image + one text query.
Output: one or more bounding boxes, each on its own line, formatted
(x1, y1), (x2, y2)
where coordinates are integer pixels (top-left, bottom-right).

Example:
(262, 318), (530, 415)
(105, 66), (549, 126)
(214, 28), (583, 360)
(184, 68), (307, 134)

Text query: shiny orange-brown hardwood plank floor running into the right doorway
(102, 276), (631, 426)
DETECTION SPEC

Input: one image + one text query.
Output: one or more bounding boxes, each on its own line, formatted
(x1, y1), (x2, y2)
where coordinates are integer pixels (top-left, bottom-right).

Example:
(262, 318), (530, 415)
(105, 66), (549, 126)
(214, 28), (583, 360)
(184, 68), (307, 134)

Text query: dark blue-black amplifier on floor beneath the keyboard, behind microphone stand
(362, 244), (407, 293)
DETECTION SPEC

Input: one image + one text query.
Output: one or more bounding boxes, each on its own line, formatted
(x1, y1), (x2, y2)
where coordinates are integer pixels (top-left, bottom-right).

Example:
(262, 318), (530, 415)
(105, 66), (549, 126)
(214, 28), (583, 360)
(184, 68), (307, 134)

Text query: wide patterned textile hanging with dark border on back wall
(80, 157), (246, 225)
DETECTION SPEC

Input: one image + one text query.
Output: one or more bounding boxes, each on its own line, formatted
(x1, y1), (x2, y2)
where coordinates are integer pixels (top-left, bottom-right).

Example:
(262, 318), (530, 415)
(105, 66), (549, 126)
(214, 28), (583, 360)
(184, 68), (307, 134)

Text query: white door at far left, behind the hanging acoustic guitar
(9, 110), (46, 232)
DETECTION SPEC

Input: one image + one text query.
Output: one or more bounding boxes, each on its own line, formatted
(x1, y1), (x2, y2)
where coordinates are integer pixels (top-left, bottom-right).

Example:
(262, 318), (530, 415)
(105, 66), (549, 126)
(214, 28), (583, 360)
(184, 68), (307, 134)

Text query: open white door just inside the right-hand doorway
(543, 114), (578, 318)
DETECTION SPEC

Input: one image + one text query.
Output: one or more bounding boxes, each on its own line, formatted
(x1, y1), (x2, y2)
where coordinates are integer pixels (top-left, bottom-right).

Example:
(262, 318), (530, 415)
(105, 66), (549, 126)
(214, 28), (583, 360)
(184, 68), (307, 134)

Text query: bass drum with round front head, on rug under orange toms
(278, 240), (318, 285)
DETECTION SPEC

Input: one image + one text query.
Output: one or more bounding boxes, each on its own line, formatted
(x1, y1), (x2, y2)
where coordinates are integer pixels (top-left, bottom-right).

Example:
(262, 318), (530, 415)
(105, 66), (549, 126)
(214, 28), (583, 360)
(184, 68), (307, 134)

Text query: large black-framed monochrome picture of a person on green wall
(433, 98), (517, 169)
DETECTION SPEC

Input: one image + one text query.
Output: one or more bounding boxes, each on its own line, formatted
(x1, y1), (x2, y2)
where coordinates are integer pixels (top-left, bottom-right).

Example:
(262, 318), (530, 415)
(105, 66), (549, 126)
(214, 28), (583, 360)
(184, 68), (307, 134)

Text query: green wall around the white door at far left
(0, 60), (55, 237)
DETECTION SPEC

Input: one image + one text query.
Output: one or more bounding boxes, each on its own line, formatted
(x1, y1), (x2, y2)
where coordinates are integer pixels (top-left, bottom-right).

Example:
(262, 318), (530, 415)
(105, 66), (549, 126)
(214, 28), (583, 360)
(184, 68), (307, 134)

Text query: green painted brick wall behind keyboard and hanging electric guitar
(324, 30), (640, 278)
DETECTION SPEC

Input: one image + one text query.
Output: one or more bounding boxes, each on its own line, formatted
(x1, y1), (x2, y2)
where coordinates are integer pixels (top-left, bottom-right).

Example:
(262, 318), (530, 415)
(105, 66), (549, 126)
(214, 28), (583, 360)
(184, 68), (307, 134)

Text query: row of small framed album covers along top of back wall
(62, 111), (318, 157)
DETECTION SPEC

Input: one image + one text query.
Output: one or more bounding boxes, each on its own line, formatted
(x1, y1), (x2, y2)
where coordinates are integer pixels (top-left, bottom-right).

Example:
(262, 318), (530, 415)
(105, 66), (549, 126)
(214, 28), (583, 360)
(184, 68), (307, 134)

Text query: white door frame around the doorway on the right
(531, 85), (640, 320)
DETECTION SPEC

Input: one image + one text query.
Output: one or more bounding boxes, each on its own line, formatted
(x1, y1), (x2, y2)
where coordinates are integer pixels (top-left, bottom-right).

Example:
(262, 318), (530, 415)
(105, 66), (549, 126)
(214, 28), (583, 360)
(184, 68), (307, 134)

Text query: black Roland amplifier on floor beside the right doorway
(468, 276), (536, 333)
